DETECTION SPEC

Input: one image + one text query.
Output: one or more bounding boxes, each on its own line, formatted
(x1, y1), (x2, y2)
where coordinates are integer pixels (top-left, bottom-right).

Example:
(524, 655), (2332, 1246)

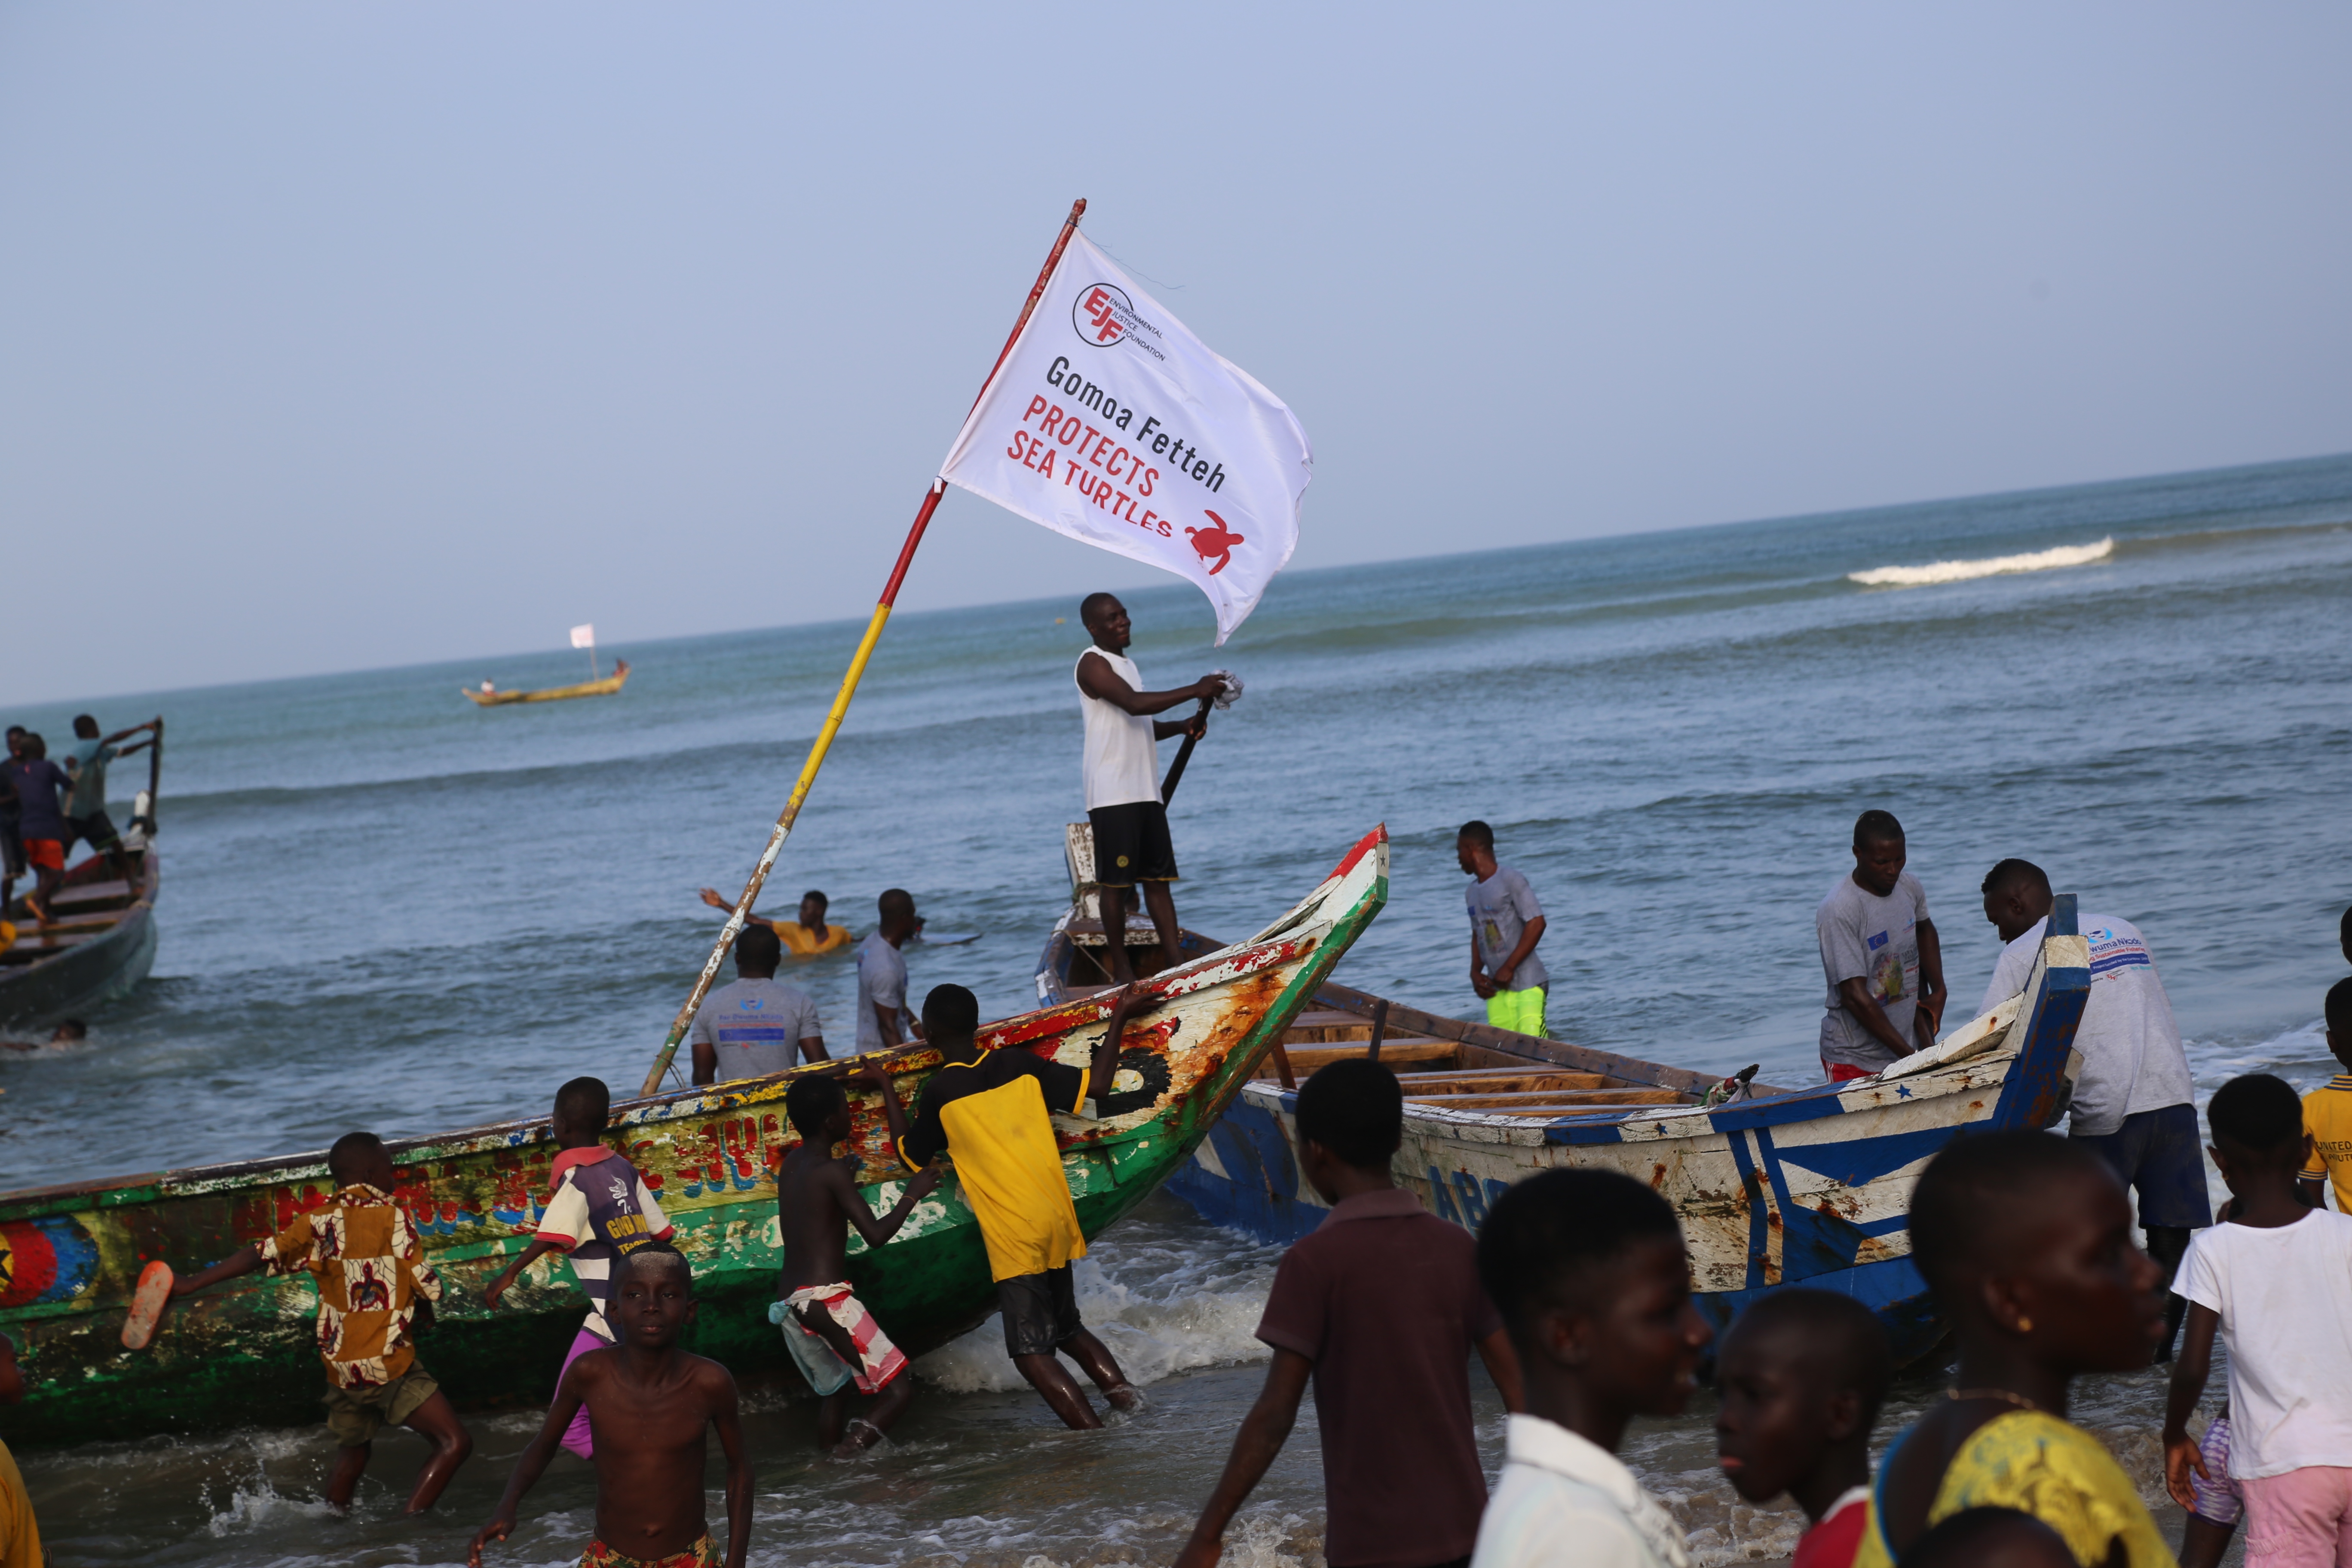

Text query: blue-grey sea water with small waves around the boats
(0, 447), (2352, 1568)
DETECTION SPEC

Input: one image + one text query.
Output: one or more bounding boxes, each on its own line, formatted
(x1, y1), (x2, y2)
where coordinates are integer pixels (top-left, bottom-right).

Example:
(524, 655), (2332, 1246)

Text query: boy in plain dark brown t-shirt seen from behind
(1176, 1058), (1519, 1568)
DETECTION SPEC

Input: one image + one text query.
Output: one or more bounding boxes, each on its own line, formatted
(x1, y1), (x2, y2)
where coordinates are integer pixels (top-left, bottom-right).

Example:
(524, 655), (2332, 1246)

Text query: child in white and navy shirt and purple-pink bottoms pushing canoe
(482, 1079), (673, 1460)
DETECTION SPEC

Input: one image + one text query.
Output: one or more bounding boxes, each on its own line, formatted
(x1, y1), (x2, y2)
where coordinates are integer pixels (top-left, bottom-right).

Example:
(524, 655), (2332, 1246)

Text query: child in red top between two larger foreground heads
(1715, 1291), (1896, 1568)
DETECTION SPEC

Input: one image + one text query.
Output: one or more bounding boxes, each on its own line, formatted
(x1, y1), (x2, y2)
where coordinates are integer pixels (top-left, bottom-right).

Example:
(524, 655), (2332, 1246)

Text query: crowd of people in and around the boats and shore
(0, 595), (2352, 1568)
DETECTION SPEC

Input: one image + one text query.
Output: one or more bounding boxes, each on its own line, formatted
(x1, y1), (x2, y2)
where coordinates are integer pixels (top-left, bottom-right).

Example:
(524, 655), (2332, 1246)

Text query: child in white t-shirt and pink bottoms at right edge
(2164, 1072), (2352, 1568)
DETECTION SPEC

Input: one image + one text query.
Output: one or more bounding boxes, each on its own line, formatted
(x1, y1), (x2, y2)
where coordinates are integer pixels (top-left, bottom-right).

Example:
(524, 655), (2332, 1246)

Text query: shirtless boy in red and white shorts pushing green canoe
(767, 1079), (941, 1460)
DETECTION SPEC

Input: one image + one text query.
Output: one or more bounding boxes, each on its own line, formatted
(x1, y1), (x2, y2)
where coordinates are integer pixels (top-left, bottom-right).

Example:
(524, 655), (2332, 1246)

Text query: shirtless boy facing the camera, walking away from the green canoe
(466, 1246), (750, 1568)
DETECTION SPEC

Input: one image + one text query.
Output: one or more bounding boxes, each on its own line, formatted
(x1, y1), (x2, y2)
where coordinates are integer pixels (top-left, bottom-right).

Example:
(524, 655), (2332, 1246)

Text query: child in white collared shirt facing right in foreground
(1470, 1168), (1712, 1568)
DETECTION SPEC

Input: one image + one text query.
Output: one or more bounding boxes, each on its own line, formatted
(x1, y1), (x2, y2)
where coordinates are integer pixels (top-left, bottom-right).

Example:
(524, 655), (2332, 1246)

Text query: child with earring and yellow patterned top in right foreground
(1853, 1131), (2173, 1568)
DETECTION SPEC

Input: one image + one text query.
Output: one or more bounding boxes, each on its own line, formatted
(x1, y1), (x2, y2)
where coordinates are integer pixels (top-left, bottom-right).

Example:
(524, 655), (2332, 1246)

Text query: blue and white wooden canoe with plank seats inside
(1037, 846), (2091, 1361)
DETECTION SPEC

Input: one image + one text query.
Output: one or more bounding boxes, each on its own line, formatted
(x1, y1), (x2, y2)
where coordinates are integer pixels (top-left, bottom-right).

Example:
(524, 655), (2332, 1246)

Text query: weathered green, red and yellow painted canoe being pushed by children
(0, 830), (1387, 1443)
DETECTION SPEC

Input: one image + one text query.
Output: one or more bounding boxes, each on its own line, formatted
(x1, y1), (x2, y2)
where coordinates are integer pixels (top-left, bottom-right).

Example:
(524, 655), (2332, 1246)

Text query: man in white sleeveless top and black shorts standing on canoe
(1075, 592), (1225, 985)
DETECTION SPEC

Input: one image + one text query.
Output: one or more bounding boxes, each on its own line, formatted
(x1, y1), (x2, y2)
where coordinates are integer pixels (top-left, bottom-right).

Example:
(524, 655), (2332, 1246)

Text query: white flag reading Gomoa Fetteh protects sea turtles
(938, 235), (1315, 642)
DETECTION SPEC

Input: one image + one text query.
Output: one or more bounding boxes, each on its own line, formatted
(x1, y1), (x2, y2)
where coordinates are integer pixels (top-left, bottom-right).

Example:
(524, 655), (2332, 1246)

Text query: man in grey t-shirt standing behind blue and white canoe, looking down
(1813, 811), (1948, 1084)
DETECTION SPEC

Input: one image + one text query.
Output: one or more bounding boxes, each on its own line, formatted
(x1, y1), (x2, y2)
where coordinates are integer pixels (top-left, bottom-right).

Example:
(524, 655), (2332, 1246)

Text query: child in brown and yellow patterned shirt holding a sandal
(172, 1133), (473, 1514)
